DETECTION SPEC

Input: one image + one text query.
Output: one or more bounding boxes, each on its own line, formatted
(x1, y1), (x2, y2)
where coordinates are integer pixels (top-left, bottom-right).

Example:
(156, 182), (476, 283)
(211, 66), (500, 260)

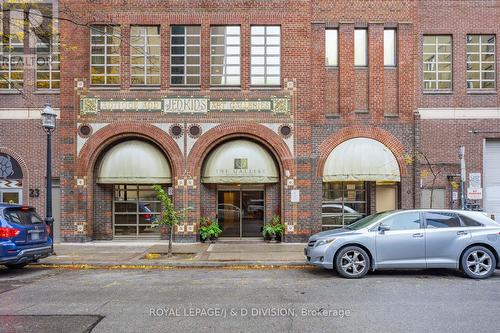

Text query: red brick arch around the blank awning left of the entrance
(77, 122), (183, 179)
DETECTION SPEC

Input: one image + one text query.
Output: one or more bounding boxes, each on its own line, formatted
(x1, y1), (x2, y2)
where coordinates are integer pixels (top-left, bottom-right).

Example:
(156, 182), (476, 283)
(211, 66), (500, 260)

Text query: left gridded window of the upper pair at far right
(423, 36), (452, 90)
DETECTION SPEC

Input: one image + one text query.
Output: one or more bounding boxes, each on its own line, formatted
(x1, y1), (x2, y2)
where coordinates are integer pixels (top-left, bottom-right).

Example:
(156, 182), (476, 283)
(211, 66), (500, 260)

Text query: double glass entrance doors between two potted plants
(217, 189), (264, 237)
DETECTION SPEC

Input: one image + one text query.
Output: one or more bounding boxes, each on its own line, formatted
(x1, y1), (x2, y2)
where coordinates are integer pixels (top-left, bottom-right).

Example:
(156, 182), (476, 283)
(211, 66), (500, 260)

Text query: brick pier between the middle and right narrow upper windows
(368, 23), (384, 122)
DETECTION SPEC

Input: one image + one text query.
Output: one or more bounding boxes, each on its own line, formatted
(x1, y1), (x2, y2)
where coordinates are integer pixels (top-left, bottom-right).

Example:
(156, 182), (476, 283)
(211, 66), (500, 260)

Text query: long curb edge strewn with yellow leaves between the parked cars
(30, 261), (313, 269)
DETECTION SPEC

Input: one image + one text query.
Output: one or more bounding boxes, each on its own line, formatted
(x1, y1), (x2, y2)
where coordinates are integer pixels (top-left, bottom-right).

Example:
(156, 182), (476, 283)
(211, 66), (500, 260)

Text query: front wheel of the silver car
(334, 246), (370, 279)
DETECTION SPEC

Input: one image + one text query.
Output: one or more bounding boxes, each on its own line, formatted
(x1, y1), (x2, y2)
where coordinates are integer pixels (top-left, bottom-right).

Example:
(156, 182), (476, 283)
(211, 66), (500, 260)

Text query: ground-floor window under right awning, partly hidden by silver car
(321, 182), (368, 230)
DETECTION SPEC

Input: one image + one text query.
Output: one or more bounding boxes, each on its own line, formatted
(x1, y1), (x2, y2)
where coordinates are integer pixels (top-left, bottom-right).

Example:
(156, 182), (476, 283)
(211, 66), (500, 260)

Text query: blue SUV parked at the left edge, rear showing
(0, 203), (52, 268)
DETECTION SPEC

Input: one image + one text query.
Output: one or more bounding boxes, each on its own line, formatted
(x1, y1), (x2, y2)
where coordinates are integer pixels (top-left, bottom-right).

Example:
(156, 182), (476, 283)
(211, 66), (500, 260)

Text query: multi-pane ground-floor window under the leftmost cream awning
(113, 185), (161, 237)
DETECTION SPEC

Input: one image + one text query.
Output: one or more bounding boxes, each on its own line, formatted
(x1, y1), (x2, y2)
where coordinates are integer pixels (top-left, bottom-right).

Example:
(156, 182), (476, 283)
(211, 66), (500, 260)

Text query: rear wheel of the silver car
(460, 246), (497, 279)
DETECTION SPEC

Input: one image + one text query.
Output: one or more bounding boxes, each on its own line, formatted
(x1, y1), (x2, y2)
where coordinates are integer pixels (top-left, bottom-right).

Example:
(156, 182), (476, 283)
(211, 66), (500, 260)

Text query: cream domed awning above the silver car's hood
(323, 138), (401, 182)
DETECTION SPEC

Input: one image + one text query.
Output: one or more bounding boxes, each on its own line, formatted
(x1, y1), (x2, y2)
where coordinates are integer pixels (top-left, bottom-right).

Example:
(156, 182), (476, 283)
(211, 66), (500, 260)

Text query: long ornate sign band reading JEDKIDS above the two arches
(80, 97), (290, 115)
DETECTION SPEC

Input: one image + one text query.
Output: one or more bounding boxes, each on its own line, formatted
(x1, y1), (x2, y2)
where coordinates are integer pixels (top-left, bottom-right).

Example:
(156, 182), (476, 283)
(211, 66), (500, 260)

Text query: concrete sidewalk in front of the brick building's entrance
(39, 241), (306, 267)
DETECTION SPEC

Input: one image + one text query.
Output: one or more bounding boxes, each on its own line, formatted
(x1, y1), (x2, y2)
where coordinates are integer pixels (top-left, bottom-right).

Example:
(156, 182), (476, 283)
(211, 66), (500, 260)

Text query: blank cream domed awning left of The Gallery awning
(97, 140), (172, 184)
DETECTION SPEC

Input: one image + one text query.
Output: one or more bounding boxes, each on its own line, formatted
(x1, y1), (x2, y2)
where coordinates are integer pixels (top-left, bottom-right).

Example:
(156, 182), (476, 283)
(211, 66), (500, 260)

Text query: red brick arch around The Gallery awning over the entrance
(188, 122), (295, 178)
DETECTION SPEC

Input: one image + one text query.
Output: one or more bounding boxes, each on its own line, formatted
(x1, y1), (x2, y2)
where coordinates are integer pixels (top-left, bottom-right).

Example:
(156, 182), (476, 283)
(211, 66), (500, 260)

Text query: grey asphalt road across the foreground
(0, 268), (500, 333)
